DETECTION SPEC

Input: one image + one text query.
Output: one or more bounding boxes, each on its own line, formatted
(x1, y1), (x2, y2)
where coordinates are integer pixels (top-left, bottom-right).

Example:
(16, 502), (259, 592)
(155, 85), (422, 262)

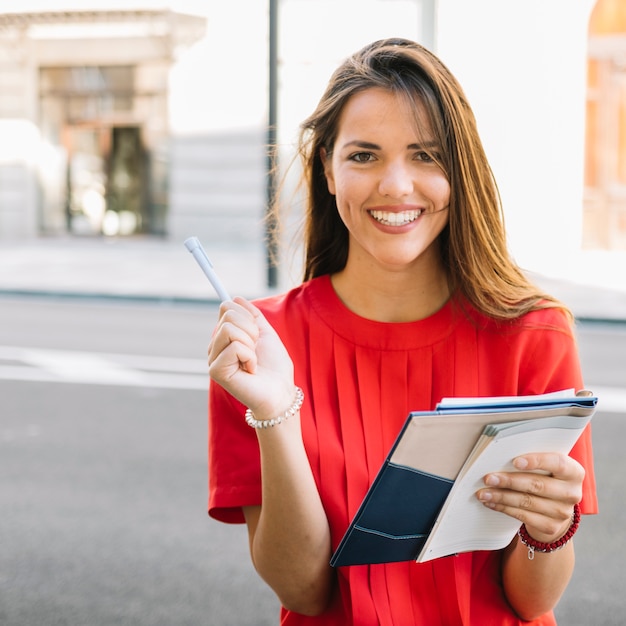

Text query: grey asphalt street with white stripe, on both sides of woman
(0, 297), (626, 626)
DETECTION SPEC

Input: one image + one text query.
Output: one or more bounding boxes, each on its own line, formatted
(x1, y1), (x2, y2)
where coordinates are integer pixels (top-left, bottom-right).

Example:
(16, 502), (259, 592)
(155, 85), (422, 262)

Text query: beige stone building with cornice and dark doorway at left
(0, 9), (206, 238)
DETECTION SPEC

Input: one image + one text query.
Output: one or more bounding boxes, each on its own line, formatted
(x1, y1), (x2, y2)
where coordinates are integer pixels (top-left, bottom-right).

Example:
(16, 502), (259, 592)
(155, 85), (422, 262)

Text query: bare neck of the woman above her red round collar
(331, 255), (450, 322)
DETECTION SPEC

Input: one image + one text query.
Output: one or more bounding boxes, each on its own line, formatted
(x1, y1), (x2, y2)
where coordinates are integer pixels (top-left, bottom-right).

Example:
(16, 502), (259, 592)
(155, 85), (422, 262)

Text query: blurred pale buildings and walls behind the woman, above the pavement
(0, 0), (626, 286)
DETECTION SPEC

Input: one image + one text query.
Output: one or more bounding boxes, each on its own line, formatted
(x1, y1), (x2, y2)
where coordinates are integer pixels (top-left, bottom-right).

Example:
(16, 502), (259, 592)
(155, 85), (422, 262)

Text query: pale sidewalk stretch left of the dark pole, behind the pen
(0, 237), (269, 302)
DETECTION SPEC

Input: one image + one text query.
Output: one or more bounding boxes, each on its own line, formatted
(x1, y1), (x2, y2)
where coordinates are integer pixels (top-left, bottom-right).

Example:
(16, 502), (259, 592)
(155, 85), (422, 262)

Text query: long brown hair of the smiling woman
(288, 39), (564, 319)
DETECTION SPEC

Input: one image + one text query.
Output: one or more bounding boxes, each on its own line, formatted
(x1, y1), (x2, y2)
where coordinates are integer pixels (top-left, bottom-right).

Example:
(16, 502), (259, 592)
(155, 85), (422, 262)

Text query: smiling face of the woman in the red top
(321, 88), (450, 270)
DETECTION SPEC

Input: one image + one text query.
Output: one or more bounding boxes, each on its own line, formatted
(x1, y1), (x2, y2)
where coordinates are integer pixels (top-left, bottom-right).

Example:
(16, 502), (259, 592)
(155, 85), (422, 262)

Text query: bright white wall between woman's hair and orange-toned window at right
(436, 0), (594, 275)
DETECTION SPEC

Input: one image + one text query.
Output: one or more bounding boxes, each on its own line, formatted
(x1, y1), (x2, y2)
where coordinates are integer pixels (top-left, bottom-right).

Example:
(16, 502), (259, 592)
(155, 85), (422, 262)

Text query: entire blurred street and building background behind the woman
(0, 0), (626, 626)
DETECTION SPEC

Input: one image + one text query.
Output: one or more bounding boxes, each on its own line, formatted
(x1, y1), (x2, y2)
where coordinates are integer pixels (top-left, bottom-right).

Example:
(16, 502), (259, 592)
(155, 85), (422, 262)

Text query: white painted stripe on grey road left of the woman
(0, 346), (208, 390)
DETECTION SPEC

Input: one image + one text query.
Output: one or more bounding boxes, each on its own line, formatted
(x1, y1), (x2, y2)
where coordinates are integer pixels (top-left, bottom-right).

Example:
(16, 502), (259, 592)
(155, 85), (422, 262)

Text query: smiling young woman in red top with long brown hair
(209, 40), (596, 626)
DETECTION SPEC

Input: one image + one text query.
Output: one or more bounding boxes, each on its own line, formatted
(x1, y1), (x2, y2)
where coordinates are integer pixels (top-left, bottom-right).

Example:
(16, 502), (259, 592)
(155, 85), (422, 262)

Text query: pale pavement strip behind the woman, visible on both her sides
(0, 237), (626, 323)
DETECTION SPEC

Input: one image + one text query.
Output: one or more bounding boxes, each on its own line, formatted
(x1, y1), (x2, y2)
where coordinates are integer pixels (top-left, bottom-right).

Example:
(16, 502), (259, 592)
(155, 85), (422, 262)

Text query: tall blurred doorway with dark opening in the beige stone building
(39, 65), (167, 236)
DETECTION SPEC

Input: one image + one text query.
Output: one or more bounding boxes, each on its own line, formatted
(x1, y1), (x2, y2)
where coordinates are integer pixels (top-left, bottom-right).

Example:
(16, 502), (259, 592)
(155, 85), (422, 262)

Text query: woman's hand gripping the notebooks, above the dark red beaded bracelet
(476, 452), (585, 543)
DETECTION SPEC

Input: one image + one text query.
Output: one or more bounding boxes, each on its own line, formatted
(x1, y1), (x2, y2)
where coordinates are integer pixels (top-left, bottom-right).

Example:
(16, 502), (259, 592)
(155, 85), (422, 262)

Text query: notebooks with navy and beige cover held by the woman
(331, 390), (597, 567)
